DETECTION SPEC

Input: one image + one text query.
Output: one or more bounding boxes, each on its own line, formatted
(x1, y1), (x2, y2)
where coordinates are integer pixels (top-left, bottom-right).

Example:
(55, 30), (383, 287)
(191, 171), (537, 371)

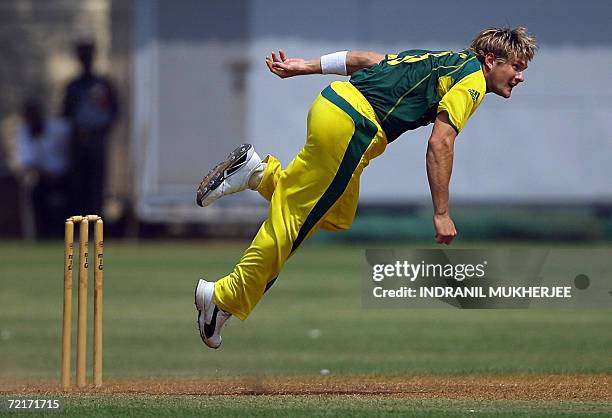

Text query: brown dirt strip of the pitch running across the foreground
(0, 375), (612, 401)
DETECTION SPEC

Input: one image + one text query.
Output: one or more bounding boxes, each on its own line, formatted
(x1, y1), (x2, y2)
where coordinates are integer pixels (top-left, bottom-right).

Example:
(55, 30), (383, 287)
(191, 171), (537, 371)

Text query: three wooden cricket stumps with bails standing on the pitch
(61, 215), (104, 389)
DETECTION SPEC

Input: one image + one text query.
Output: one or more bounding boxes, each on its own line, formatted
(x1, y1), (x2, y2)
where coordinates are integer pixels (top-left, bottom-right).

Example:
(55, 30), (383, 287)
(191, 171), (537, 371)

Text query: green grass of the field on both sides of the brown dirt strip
(0, 241), (612, 416)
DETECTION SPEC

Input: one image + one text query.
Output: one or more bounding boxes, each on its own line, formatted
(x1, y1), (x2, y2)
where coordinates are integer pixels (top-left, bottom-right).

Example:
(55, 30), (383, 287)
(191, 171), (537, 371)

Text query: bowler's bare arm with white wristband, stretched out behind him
(266, 50), (385, 78)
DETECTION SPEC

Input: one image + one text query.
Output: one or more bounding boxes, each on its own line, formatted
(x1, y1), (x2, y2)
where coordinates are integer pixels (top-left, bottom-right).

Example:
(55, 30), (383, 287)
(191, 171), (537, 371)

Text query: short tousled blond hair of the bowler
(470, 26), (538, 62)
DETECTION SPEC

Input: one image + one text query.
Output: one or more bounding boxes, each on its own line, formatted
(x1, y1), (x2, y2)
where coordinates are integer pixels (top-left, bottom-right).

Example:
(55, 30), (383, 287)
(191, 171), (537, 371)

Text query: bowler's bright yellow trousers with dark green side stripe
(215, 81), (387, 320)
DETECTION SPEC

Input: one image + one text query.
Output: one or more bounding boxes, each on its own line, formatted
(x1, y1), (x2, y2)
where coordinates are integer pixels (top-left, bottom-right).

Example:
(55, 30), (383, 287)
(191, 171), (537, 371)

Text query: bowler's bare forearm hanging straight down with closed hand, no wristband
(427, 112), (457, 245)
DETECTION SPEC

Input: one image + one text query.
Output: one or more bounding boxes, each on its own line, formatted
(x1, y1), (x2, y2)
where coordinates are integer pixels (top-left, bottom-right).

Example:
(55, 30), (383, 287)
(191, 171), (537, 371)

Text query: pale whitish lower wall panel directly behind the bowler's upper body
(248, 42), (612, 203)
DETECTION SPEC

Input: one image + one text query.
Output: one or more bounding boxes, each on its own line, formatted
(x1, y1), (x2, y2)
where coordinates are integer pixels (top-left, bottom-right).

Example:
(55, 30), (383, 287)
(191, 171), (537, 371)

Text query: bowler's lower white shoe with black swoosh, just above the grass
(195, 279), (232, 348)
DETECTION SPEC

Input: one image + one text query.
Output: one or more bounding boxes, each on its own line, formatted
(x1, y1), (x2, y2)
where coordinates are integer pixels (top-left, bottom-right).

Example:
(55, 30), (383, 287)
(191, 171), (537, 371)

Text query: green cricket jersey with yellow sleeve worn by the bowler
(350, 49), (486, 142)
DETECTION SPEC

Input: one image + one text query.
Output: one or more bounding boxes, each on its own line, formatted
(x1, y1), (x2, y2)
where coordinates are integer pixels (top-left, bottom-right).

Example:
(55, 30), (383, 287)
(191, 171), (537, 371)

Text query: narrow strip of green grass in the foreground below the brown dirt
(0, 395), (612, 417)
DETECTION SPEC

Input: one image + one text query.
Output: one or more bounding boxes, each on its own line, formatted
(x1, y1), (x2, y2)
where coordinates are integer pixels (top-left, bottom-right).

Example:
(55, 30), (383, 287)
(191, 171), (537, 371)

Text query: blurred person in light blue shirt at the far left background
(16, 99), (70, 238)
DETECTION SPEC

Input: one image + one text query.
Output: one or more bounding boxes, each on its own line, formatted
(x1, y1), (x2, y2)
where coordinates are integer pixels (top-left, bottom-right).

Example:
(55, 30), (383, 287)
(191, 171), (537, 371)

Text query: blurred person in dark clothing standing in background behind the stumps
(62, 42), (118, 215)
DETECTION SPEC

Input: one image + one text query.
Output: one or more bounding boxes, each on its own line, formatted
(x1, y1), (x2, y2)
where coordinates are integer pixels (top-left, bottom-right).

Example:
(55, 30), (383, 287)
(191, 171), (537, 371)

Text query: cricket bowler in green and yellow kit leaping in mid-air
(195, 27), (537, 348)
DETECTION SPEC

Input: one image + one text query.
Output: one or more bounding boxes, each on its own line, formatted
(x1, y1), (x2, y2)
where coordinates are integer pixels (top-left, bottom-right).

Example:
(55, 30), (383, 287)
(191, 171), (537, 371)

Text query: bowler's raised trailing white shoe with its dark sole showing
(196, 144), (265, 207)
